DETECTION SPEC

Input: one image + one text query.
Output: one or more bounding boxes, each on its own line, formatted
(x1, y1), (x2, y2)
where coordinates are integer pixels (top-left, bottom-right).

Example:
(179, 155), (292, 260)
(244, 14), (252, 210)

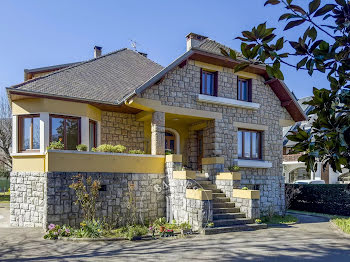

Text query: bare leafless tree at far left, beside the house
(0, 98), (12, 172)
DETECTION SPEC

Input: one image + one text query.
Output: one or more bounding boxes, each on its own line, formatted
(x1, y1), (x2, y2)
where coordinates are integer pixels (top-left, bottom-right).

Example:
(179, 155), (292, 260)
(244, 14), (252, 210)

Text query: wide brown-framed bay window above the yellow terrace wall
(50, 115), (80, 150)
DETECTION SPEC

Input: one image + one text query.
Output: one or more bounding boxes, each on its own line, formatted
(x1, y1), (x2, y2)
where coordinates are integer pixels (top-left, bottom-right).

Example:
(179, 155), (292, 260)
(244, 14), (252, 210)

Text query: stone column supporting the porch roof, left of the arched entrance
(151, 112), (165, 155)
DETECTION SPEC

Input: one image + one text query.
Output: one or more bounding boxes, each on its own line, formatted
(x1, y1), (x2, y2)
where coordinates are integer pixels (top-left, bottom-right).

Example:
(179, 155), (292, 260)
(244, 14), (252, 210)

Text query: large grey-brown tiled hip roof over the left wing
(11, 48), (163, 104)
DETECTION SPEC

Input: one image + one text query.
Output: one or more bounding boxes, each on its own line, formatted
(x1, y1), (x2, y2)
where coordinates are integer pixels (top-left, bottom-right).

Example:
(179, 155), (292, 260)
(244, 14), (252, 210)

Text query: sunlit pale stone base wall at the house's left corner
(10, 172), (47, 227)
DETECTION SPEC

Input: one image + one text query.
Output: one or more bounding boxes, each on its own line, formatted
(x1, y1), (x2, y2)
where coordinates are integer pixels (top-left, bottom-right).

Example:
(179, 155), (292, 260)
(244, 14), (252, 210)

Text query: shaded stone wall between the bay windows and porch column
(101, 111), (144, 151)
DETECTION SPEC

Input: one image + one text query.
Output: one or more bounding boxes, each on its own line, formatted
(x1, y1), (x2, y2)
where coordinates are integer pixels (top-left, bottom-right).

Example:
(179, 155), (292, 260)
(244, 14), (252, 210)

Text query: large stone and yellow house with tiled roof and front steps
(7, 33), (306, 233)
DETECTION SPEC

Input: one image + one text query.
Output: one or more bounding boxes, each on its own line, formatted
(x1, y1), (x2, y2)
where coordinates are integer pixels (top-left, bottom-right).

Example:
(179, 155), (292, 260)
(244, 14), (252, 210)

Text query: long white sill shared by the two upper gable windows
(197, 94), (260, 110)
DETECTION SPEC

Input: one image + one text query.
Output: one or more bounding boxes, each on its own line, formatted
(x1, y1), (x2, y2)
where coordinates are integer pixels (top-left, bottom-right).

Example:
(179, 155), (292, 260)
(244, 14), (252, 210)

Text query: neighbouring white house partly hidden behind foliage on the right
(283, 96), (349, 184)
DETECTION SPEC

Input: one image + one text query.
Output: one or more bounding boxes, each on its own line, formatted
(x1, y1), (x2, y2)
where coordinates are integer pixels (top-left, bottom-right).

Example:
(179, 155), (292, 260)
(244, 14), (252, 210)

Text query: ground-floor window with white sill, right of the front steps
(238, 130), (262, 159)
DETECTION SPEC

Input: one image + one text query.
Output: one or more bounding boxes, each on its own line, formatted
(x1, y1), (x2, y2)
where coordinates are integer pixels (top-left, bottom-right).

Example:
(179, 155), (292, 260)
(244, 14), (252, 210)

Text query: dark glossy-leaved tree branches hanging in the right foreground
(221, 0), (350, 172)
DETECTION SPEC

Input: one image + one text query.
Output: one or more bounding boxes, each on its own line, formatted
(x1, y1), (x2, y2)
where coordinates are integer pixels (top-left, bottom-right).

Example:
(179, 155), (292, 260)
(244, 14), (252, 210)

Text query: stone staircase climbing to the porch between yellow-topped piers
(196, 173), (267, 235)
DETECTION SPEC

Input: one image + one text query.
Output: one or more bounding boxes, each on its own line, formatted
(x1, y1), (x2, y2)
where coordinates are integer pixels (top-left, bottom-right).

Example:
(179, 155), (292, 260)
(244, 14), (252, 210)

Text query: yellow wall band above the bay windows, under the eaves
(12, 98), (101, 121)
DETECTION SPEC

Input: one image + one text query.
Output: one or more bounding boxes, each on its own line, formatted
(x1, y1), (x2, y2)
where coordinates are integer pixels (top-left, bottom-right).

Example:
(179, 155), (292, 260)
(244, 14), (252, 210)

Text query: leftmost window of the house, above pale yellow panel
(18, 115), (40, 151)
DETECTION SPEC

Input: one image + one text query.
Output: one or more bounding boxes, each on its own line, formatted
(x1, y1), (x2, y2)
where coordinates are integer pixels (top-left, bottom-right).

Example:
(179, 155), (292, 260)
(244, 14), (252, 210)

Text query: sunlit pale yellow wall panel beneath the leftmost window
(12, 155), (45, 172)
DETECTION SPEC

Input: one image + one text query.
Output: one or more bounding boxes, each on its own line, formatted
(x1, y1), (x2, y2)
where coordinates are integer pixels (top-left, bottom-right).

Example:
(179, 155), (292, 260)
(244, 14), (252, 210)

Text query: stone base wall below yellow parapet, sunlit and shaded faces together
(10, 172), (166, 227)
